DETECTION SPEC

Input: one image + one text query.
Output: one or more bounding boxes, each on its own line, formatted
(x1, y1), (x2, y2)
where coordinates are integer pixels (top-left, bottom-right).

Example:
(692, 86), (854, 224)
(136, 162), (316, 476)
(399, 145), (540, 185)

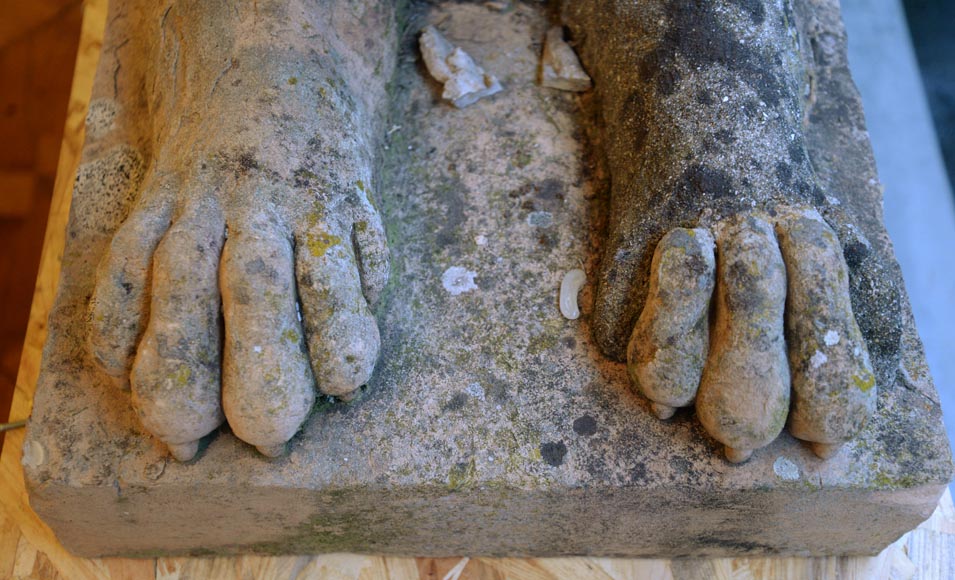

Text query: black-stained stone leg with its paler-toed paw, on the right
(563, 0), (901, 462)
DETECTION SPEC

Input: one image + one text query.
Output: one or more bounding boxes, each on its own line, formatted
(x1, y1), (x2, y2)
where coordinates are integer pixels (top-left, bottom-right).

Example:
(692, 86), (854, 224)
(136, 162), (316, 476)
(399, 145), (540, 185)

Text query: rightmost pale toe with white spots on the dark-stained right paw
(776, 210), (876, 459)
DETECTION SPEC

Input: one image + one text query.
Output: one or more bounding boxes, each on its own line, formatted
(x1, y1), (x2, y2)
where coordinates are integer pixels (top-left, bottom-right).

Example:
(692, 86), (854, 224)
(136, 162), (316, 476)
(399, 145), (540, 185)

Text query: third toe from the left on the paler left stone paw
(220, 217), (315, 456)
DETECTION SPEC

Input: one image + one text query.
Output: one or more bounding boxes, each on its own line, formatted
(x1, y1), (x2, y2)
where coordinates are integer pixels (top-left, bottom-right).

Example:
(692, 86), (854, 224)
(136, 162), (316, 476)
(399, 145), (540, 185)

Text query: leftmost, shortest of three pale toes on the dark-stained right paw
(627, 228), (716, 419)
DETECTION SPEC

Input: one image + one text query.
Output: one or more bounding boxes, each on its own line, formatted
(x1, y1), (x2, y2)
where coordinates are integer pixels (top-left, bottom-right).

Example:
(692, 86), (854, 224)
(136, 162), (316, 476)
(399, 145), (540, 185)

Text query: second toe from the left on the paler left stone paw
(130, 200), (224, 461)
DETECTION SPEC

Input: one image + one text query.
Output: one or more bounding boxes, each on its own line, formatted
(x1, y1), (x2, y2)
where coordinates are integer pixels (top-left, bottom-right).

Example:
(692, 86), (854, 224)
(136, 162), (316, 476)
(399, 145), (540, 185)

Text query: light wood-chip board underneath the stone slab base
(0, 0), (955, 580)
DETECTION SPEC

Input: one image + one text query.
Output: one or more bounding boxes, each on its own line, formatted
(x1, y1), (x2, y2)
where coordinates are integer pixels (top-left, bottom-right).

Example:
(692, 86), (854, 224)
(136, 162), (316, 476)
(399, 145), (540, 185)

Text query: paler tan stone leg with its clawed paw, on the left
(83, 0), (396, 461)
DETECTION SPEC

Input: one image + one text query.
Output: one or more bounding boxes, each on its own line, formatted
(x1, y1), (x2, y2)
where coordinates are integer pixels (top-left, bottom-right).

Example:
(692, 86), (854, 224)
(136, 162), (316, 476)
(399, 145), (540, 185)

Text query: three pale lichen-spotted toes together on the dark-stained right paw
(627, 208), (875, 463)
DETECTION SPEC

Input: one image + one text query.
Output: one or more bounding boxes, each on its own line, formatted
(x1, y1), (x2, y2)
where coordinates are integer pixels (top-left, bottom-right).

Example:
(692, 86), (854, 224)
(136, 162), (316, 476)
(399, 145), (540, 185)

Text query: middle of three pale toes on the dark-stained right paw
(696, 216), (790, 463)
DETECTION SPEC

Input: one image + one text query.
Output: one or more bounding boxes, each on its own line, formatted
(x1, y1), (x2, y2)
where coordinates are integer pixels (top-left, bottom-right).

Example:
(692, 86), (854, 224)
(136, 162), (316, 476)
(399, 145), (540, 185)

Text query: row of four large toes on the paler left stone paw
(89, 193), (379, 461)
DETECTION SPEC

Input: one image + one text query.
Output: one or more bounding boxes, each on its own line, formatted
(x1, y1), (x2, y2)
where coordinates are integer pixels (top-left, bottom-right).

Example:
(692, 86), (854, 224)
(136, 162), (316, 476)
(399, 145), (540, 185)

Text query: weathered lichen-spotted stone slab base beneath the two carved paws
(24, 0), (952, 558)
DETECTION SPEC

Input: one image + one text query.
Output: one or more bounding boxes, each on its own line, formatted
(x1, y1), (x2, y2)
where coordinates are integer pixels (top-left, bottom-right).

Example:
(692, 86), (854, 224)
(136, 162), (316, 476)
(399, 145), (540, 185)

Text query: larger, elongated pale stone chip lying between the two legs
(419, 26), (502, 109)
